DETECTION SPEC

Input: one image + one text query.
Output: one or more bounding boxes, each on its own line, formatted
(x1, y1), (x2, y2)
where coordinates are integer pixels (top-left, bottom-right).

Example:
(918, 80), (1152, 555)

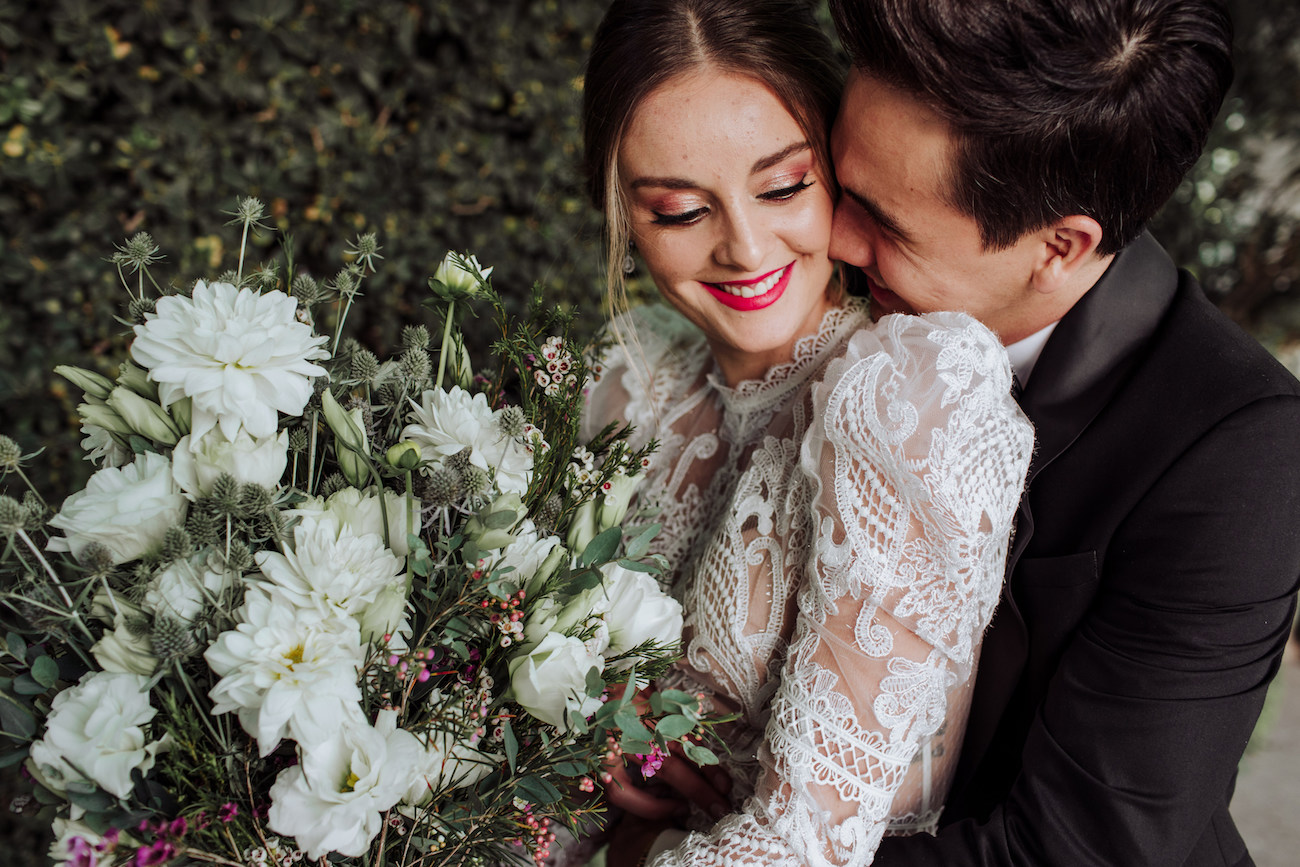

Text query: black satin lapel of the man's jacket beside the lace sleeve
(953, 233), (1178, 798)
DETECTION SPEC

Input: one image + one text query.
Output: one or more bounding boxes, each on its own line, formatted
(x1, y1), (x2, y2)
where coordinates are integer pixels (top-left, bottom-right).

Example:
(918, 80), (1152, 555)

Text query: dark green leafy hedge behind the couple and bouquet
(0, 0), (1300, 863)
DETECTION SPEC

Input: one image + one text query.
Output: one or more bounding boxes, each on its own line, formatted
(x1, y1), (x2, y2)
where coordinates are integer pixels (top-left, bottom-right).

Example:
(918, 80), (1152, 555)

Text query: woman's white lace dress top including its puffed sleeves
(588, 305), (1032, 867)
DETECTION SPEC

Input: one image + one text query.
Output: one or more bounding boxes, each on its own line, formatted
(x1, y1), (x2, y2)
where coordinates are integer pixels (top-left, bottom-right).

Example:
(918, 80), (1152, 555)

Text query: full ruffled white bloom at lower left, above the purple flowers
(29, 672), (163, 798)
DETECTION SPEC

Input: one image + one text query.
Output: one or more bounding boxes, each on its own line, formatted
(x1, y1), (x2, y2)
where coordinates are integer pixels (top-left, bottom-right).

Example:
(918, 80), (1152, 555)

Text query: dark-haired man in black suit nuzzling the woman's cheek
(831, 0), (1300, 867)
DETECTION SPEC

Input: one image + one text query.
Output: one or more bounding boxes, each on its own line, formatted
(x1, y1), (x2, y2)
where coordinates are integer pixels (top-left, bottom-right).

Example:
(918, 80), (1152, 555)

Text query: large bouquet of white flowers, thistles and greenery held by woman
(0, 199), (716, 867)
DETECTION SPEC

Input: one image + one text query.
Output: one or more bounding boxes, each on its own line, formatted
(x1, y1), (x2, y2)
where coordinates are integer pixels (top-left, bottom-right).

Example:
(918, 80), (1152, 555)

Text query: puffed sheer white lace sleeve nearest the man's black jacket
(654, 313), (1032, 867)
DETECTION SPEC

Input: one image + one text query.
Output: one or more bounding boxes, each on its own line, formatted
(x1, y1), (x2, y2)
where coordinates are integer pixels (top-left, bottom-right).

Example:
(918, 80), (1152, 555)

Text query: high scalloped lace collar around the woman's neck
(707, 298), (870, 415)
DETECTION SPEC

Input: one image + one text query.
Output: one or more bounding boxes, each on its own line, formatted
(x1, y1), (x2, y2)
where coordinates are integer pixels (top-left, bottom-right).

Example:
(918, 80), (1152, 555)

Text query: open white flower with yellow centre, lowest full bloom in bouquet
(267, 711), (420, 859)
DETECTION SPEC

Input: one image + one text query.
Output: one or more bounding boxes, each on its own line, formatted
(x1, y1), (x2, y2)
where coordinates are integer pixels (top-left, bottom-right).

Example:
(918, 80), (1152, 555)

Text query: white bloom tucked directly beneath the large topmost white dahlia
(172, 428), (289, 499)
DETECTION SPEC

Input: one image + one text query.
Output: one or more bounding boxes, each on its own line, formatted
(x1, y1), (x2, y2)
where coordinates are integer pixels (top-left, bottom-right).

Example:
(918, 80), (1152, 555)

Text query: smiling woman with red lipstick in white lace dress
(584, 0), (1032, 867)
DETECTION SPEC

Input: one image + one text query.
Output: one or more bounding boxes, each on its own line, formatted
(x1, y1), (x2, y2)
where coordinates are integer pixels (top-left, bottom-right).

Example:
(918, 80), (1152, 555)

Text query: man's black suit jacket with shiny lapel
(875, 235), (1300, 867)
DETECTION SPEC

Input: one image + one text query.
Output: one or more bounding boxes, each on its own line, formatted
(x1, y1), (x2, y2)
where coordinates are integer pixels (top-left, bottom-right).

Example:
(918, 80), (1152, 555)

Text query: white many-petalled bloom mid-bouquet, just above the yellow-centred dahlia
(254, 515), (406, 616)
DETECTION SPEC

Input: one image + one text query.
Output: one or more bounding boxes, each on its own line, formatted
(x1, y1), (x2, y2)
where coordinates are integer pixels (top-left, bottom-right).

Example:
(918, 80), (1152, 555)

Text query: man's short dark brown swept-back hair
(831, 0), (1232, 255)
